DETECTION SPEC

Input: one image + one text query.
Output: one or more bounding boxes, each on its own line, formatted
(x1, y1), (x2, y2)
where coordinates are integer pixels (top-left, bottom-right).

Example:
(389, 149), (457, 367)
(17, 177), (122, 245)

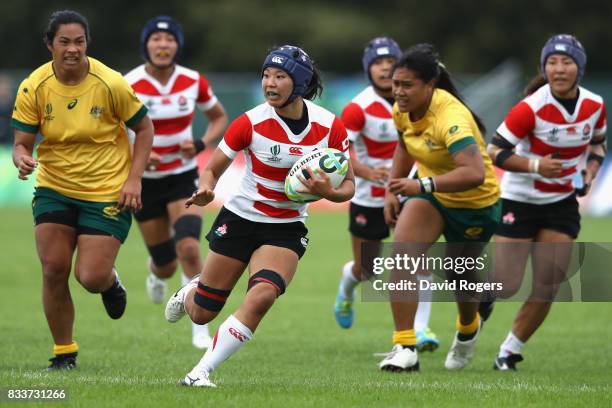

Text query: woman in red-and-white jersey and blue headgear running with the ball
(166, 45), (355, 387)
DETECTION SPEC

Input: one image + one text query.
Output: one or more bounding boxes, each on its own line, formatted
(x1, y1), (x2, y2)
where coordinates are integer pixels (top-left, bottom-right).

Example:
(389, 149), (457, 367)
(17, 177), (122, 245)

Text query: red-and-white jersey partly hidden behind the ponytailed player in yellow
(342, 86), (397, 207)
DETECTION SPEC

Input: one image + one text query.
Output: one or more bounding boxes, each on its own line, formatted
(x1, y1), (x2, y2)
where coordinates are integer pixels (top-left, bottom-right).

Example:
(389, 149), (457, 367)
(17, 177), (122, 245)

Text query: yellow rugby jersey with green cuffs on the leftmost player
(11, 58), (147, 201)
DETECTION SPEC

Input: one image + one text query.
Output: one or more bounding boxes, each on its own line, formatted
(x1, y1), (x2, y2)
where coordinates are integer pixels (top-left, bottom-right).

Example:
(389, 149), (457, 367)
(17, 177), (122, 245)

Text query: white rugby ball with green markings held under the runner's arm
(285, 147), (349, 203)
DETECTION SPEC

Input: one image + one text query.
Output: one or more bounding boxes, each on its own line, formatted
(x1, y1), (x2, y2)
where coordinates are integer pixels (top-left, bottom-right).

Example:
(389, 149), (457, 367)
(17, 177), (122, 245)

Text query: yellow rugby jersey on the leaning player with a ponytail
(393, 89), (500, 209)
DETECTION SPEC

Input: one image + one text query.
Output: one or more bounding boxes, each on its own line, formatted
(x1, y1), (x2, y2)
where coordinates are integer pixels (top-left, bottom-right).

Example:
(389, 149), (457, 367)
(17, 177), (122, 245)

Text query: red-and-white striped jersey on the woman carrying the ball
(219, 100), (349, 223)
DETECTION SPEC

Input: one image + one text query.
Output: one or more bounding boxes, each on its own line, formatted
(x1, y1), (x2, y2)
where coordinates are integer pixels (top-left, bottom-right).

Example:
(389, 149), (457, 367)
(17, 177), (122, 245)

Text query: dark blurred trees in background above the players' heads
(0, 0), (612, 75)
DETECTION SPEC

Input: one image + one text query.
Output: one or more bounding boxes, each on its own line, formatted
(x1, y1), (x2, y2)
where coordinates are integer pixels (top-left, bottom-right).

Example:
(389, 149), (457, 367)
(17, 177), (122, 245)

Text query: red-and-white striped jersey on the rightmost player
(497, 84), (606, 204)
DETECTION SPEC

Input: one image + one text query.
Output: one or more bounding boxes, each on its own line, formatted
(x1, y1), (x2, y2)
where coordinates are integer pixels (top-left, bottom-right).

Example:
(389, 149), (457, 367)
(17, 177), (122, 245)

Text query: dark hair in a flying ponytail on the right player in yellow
(393, 44), (486, 135)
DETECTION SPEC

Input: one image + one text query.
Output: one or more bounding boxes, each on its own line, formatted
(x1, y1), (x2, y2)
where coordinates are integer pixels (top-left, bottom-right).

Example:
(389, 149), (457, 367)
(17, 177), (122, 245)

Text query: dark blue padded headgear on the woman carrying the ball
(261, 45), (314, 108)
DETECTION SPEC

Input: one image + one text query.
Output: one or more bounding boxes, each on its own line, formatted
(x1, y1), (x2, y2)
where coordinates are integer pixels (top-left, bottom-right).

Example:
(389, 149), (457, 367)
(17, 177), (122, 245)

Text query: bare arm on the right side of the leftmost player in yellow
(117, 115), (153, 210)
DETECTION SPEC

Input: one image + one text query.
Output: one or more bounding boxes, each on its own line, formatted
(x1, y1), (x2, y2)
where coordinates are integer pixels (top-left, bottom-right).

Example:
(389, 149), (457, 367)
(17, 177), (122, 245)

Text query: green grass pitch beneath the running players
(0, 209), (612, 407)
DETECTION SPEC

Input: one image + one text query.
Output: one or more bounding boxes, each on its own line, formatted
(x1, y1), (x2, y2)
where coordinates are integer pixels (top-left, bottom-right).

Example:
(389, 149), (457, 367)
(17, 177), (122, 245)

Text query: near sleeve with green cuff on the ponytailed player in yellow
(439, 108), (477, 154)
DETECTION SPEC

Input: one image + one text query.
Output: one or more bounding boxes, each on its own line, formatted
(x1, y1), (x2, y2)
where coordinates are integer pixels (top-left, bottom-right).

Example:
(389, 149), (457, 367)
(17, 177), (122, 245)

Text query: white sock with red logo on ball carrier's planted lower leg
(190, 315), (253, 375)
